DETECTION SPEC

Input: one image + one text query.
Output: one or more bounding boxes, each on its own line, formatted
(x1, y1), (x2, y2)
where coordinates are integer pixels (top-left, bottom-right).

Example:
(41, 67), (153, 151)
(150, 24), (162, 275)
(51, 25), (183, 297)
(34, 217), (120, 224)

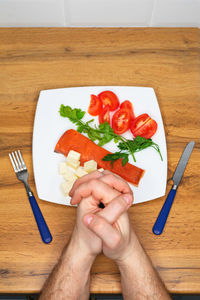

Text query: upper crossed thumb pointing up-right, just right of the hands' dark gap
(98, 194), (133, 224)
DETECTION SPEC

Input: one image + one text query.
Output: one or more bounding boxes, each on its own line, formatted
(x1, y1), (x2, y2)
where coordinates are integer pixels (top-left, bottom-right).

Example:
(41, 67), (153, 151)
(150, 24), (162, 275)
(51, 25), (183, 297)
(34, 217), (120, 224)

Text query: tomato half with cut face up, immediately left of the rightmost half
(112, 108), (131, 134)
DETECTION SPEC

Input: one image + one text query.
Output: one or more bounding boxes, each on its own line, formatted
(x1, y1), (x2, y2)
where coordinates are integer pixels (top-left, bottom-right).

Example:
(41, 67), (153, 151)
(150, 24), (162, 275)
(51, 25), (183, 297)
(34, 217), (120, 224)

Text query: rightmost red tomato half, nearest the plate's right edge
(131, 114), (157, 139)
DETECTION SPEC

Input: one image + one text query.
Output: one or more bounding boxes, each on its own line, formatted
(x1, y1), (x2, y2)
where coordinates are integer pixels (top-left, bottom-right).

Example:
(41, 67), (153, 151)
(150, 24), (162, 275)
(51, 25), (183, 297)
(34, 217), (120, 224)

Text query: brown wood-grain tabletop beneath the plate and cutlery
(0, 28), (200, 293)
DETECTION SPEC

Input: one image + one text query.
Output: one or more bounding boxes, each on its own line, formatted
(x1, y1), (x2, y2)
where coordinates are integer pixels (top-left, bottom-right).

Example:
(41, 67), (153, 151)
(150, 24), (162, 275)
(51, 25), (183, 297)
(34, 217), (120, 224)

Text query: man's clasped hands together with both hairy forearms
(40, 171), (170, 300)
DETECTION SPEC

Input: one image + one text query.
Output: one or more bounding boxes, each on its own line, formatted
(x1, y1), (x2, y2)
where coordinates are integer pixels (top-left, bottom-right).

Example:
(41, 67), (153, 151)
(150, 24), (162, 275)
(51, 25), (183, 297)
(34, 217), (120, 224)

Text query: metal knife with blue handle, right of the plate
(152, 141), (195, 235)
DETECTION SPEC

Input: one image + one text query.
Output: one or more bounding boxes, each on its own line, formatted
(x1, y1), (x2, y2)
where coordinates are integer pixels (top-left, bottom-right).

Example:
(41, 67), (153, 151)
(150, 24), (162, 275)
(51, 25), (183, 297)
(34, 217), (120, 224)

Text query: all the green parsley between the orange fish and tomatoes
(59, 104), (163, 166)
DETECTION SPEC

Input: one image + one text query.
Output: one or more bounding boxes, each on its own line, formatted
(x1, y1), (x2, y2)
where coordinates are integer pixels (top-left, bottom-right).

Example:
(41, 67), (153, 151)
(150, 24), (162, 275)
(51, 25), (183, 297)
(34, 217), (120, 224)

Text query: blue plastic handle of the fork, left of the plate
(29, 196), (52, 244)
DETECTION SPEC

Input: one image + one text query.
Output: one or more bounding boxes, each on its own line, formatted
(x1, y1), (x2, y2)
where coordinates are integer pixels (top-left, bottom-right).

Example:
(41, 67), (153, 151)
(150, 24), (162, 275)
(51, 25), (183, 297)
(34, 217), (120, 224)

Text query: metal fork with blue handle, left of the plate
(9, 150), (52, 244)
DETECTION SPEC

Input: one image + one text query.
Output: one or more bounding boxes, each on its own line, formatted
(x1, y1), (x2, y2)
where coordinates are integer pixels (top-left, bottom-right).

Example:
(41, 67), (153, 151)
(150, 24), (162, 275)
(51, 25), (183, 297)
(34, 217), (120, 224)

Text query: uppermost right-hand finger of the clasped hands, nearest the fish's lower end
(99, 172), (132, 194)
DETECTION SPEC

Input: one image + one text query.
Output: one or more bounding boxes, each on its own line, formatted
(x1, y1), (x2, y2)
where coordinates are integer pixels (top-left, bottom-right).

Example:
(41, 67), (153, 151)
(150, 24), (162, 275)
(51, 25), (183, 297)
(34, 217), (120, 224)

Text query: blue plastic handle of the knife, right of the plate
(152, 189), (176, 235)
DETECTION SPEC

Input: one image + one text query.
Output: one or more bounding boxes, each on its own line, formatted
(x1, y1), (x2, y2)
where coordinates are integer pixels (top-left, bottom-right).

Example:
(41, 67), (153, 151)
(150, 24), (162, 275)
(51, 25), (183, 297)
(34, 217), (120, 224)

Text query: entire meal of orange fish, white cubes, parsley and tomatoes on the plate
(55, 91), (162, 194)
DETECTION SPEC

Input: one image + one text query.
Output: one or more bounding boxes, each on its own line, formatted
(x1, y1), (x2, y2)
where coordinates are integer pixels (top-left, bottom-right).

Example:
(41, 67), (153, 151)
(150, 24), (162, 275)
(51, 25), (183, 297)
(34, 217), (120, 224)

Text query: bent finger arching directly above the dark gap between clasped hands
(71, 179), (120, 204)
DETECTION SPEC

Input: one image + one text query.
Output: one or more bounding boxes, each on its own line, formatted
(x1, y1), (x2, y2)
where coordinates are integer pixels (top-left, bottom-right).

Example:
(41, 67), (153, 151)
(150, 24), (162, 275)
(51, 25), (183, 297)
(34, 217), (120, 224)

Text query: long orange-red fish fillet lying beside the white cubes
(55, 129), (144, 186)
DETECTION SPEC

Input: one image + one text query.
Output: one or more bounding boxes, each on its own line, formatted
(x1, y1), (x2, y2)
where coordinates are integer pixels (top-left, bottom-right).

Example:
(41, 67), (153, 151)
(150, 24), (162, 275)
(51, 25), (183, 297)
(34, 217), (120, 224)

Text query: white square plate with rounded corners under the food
(33, 86), (167, 205)
